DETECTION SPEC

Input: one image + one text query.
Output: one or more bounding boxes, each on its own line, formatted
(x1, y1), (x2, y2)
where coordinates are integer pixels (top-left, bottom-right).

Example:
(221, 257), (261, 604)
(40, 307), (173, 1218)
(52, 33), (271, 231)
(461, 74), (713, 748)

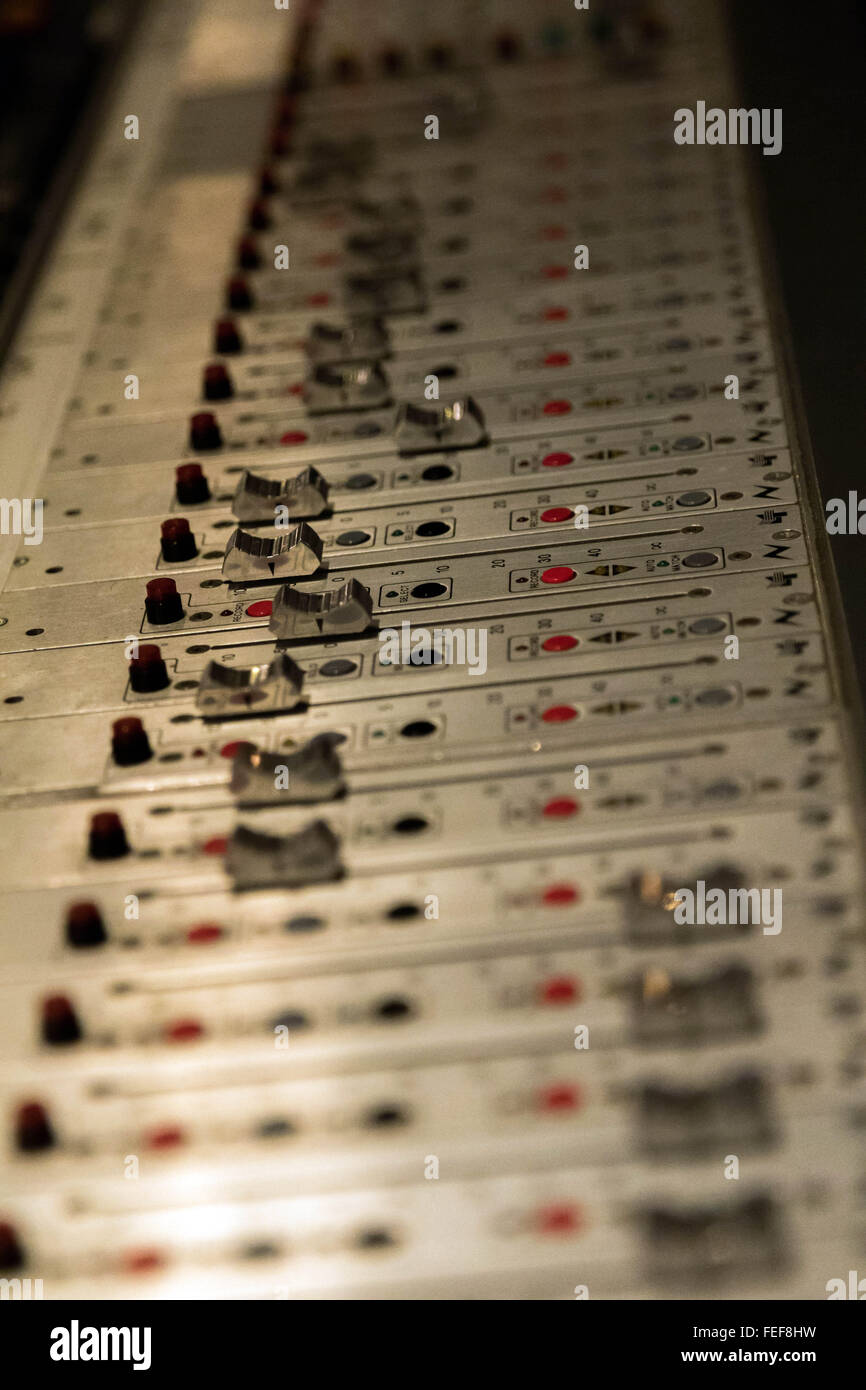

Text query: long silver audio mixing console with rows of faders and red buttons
(0, 0), (866, 1300)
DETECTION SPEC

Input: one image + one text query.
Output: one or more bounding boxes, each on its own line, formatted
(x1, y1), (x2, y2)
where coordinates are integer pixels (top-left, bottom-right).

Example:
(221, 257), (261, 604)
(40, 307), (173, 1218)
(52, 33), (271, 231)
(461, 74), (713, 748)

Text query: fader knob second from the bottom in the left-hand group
(229, 734), (346, 806)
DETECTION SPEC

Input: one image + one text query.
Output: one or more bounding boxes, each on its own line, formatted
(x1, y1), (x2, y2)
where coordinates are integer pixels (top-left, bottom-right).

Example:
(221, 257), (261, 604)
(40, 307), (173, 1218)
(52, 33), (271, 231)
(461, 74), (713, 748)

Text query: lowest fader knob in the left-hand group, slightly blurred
(225, 820), (342, 888)
